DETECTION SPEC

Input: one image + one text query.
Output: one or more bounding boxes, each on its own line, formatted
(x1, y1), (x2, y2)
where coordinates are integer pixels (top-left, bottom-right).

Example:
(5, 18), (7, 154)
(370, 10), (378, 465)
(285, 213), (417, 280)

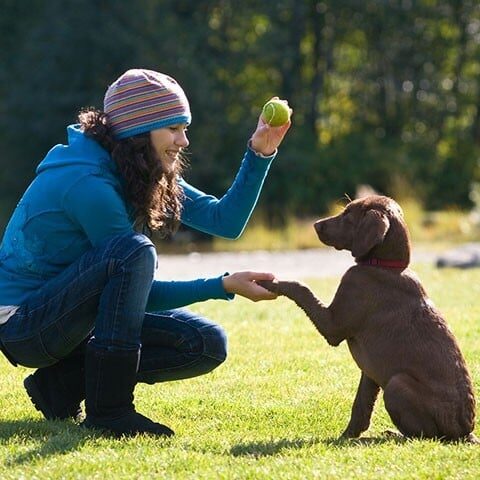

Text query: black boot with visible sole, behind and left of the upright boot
(23, 346), (85, 420)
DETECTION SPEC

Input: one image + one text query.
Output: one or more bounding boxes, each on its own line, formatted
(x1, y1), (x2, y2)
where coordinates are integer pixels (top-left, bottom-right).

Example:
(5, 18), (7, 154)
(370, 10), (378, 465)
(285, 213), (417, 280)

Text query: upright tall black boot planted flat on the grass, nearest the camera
(83, 344), (174, 436)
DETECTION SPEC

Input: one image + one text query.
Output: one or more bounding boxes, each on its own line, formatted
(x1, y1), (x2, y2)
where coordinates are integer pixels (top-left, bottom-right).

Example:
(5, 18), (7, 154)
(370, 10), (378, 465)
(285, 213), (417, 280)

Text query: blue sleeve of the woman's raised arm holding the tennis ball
(179, 144), (275, 239)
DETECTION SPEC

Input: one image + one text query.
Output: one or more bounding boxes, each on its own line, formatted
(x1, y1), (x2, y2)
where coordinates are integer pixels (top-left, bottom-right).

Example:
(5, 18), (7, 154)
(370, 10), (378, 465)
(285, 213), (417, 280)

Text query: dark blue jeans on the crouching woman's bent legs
(0, 233), (227, 383)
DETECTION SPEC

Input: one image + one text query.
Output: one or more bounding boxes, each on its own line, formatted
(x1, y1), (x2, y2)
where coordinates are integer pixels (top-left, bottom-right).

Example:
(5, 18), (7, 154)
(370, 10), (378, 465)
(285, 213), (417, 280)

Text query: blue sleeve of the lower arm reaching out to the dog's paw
(146, 275), (235, 312)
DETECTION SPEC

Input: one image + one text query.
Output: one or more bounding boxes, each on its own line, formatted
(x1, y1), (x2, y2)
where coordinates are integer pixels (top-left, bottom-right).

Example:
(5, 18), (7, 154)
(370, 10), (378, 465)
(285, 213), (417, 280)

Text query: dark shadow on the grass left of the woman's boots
(0, 420), (98, 465)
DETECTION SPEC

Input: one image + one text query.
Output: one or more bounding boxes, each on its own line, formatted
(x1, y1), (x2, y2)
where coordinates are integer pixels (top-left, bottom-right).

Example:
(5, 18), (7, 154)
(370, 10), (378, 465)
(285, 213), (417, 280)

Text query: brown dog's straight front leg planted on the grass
(340, 372), (380, 438)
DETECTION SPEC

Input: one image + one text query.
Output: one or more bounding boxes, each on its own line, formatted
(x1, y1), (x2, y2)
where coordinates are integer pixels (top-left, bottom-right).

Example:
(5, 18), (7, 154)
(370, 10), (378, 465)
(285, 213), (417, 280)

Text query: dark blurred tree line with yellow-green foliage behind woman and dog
(0, 0), (480, 229)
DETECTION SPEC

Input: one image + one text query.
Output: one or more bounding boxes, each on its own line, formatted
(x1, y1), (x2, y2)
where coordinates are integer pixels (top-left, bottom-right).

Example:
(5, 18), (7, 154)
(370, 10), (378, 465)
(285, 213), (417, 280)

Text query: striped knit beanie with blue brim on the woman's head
(103, 69), (192, 140)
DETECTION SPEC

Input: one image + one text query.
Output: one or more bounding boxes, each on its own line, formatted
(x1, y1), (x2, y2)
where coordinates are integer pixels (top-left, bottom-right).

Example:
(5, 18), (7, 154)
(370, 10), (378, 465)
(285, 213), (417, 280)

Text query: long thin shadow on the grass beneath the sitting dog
(230, 435), (407, 457)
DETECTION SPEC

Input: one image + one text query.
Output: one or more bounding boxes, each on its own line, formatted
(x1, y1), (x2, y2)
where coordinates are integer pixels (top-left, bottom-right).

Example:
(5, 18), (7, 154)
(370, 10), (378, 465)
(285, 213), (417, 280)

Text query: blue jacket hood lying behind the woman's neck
(36, 124), (117, 175)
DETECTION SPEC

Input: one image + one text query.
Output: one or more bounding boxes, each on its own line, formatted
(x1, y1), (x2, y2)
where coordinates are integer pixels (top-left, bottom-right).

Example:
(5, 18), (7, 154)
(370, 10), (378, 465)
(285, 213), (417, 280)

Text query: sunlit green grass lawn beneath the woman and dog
(0, 266), (480, 480)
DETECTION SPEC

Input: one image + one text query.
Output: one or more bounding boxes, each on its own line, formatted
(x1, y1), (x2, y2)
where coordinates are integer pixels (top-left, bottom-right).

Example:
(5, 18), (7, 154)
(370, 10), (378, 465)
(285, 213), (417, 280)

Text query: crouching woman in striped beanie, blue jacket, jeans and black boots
(0, 69), (290, 435)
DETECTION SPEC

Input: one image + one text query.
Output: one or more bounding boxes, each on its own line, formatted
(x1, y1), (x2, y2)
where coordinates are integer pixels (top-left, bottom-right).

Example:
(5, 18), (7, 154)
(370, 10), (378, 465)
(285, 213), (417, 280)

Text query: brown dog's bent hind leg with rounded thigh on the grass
(383, 373), (442, 438)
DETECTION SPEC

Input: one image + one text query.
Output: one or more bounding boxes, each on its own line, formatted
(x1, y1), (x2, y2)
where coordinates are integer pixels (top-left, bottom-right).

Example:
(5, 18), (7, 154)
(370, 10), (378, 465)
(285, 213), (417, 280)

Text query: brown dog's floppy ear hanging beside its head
(352, 210), (390, 258)
